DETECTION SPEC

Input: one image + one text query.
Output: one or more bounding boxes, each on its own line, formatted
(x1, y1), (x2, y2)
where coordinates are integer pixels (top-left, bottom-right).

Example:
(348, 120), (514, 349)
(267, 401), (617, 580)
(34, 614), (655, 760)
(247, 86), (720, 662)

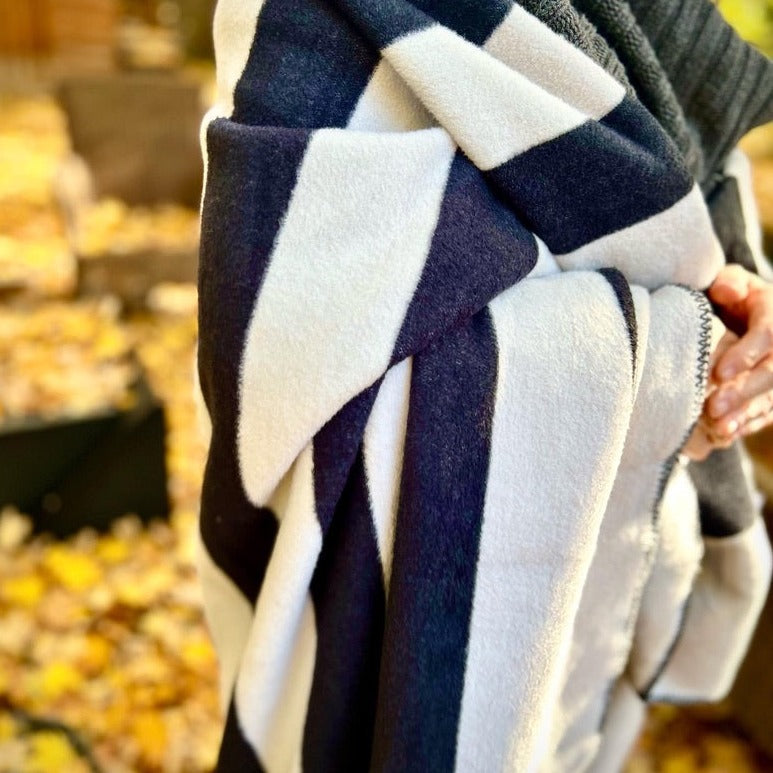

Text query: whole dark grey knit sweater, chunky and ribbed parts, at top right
(573, 0), (773, 193)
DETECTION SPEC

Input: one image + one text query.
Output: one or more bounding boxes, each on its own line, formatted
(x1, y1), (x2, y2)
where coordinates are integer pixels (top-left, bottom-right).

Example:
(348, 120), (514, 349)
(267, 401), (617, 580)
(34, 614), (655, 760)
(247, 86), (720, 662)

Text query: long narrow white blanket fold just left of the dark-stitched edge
(550, 287), (702, 770)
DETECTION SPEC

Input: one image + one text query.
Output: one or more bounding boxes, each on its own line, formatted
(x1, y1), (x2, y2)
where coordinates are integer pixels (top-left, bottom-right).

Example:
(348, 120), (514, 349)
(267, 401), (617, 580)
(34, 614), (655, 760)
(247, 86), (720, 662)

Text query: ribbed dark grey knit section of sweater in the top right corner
(629, 0), (773, 188)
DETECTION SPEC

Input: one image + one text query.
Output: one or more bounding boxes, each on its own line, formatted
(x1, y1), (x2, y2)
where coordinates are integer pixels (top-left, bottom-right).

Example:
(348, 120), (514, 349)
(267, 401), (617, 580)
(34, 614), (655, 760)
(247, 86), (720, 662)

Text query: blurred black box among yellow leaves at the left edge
(0, 378), (169, 537)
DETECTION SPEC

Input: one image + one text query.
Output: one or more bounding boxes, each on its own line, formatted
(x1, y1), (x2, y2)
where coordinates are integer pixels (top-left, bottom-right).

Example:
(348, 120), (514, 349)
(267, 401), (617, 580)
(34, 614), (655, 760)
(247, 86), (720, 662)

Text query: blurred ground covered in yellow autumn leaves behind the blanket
(0, 99), (773, 773)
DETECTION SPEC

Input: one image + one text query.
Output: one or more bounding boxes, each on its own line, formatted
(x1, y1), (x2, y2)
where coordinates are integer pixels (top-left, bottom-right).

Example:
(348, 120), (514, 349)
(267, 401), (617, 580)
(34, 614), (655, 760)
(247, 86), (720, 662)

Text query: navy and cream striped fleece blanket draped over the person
(198, 0), (770, 773)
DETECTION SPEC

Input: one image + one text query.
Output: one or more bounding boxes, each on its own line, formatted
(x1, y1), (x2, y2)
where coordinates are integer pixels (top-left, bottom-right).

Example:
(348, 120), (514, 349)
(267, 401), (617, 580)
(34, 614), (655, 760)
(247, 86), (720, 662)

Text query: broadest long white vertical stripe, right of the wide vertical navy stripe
(456, 273), (632, 773)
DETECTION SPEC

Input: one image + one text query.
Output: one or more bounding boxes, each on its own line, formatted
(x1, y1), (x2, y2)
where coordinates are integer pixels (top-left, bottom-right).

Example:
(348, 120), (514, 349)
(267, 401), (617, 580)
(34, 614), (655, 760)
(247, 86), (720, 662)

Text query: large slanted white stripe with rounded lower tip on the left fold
(239, 129), (455, 505)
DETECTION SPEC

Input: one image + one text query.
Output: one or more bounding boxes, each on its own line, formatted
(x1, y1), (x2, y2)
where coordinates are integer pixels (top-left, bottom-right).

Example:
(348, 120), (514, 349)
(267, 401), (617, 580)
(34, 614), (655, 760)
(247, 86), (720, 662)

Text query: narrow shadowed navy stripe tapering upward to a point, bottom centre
(303, 450), (386, 773)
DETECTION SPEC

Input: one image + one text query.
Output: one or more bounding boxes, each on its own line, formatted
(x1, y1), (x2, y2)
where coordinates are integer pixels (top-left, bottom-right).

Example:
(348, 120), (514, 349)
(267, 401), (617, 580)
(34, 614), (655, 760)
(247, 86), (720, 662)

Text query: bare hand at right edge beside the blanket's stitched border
(684, 266), (773, 459)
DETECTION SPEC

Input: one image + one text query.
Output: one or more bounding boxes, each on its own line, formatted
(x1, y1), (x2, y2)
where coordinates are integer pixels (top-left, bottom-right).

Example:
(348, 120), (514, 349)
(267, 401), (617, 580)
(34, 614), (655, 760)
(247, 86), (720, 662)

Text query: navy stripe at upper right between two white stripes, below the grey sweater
(488, 98), (694, 254)
